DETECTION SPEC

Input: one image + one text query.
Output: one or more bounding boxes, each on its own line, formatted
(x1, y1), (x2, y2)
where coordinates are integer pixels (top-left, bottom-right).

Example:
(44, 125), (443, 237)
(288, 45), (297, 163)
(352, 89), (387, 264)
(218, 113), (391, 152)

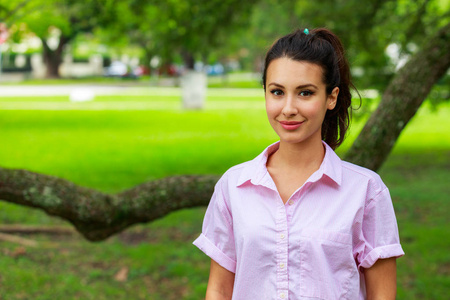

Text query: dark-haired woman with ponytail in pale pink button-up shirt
(194, 29), (404, 300)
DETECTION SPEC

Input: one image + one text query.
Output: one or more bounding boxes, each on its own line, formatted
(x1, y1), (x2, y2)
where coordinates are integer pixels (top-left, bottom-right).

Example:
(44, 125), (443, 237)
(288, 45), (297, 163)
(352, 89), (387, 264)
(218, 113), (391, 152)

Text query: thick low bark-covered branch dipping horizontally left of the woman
(0, 168), (218, 241)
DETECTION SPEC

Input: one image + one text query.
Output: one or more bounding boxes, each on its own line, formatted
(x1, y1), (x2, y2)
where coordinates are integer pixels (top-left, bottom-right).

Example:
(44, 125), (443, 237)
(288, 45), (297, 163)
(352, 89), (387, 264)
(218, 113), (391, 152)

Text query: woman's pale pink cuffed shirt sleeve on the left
(193, 179), (236, 273)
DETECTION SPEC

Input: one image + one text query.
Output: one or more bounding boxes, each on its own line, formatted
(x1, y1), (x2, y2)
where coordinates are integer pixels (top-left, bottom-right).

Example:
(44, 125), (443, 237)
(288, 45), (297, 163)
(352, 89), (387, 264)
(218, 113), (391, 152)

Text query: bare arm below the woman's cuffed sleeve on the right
(364, 257), (397, 300)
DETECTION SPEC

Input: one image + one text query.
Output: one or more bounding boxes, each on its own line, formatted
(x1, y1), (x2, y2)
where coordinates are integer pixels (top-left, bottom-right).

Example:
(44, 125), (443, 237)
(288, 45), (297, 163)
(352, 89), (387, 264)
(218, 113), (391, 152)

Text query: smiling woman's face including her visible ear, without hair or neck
(265, 57), (339, 143)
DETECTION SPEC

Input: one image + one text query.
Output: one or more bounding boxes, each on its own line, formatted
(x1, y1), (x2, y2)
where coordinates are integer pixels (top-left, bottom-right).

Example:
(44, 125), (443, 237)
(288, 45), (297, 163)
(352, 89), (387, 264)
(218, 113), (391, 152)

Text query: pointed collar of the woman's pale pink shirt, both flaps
(237, 141), (342, 186)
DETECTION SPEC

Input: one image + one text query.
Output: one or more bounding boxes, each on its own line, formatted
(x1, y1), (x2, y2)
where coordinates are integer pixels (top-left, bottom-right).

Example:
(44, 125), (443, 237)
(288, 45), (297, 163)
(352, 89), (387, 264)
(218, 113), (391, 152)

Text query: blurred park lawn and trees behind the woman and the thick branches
(0, 0), (450, 299)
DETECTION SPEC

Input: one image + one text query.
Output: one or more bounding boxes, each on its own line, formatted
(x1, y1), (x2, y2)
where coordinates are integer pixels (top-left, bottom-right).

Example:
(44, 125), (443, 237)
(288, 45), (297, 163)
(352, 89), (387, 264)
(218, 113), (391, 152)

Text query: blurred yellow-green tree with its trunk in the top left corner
(0, 0), (116, 78)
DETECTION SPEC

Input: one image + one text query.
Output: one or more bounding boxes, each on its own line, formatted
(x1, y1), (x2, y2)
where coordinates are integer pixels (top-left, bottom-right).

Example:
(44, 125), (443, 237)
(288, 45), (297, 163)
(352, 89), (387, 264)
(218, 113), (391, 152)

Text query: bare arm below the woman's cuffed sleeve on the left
(206, 259), (234, 300)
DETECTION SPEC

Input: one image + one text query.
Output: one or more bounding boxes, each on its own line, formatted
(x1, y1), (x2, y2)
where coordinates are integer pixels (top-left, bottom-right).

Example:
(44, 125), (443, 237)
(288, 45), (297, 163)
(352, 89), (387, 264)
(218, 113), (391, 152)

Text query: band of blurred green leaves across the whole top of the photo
(4, 0), (450, 92)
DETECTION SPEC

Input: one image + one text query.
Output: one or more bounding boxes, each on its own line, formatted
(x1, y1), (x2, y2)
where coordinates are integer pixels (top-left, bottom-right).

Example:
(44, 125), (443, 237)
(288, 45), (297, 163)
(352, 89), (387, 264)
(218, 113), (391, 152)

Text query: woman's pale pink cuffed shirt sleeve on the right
(354, 188), (405, 268)
